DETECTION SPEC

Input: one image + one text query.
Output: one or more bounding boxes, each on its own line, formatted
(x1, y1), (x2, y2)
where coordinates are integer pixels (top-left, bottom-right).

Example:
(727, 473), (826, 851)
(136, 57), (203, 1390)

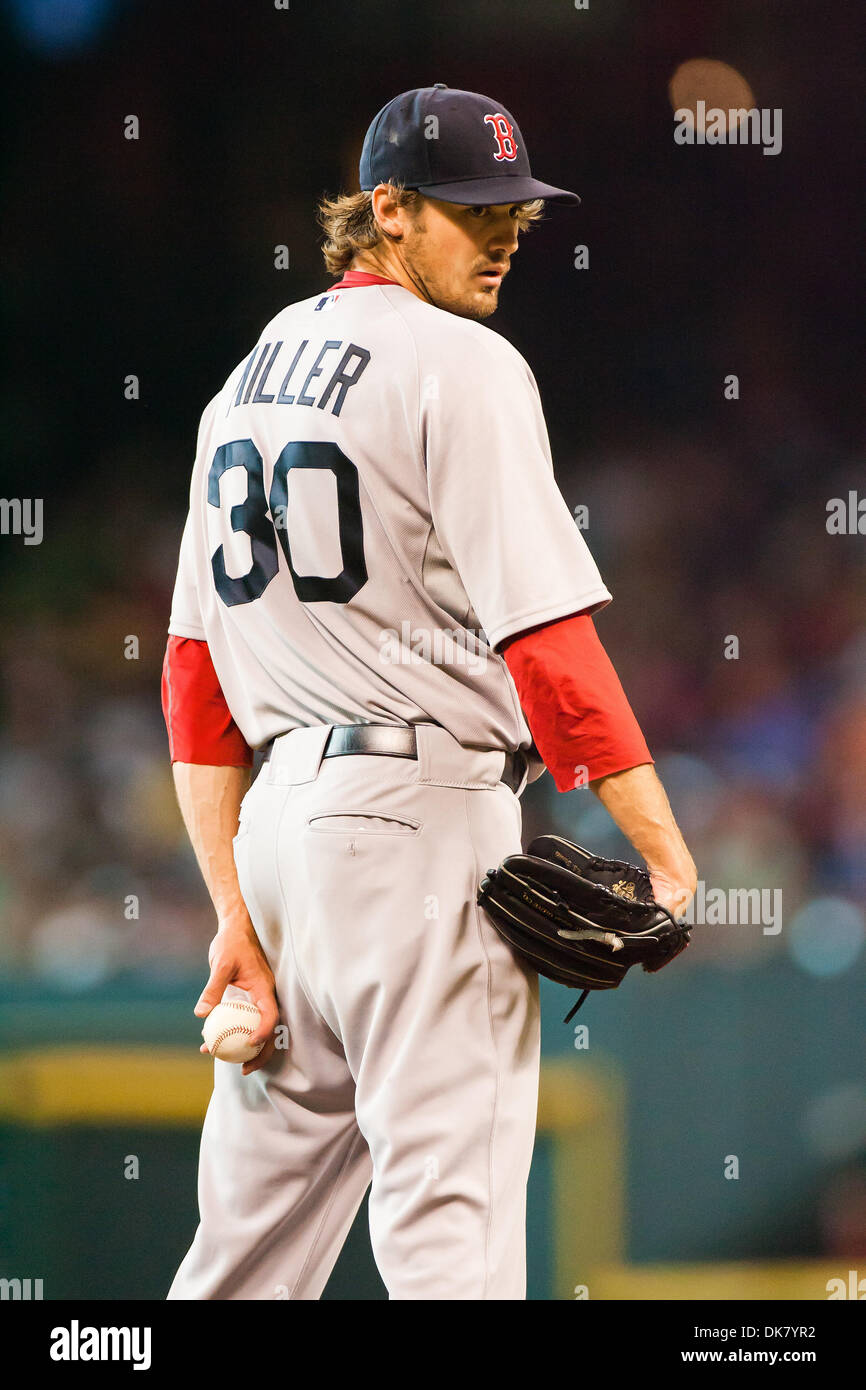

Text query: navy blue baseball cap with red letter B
(359, 82), (580, 206)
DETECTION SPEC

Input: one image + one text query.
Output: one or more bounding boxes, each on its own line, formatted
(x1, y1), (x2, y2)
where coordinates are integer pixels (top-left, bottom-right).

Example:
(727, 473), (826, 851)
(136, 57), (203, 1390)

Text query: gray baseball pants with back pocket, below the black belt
(168, 726), (539, 1300)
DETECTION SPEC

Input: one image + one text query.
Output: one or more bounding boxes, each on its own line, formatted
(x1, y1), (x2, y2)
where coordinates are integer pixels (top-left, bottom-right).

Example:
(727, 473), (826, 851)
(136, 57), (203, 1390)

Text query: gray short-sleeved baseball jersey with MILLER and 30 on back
(168, 284), (610, 749)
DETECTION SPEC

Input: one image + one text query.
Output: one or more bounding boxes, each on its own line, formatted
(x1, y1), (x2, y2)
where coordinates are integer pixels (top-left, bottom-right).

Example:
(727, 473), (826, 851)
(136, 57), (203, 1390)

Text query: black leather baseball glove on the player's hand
(478, 835), (691, 1023)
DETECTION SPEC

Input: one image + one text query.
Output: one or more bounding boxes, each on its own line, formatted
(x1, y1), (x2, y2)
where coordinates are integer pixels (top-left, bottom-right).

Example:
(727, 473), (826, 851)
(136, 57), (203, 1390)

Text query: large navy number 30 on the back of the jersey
(207, 439), (367, 607)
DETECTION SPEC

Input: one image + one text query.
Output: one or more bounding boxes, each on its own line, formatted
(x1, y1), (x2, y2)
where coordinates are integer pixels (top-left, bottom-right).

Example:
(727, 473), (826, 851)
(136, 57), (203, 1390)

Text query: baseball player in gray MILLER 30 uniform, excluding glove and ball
(163, 83), (695, 1300)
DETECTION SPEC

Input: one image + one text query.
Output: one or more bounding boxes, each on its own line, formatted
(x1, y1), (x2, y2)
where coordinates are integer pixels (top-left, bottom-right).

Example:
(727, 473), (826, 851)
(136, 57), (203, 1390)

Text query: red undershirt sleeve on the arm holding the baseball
(163, 635), (253, 767)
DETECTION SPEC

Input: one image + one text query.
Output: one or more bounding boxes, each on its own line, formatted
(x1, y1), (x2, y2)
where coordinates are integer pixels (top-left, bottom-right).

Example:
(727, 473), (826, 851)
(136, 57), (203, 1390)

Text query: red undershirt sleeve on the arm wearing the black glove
(502, 613), (653, 791)
